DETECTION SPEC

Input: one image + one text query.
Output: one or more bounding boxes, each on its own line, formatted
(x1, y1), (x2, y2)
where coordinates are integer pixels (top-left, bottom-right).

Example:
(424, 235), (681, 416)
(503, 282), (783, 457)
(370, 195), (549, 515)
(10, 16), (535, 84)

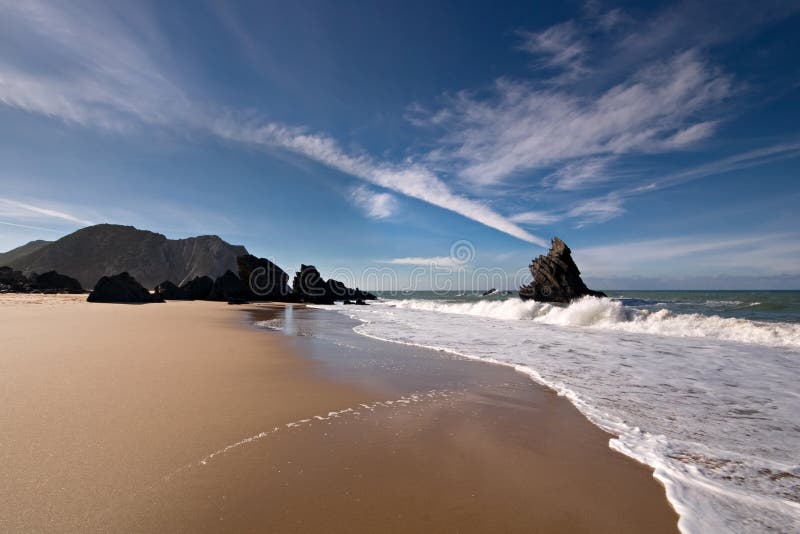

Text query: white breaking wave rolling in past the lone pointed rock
(386, 297), (800, 349)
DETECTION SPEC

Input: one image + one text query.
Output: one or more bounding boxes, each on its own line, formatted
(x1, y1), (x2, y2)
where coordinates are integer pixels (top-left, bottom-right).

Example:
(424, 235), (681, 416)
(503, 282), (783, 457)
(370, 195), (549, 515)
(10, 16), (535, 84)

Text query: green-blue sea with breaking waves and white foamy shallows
(312, 291), (800, 533)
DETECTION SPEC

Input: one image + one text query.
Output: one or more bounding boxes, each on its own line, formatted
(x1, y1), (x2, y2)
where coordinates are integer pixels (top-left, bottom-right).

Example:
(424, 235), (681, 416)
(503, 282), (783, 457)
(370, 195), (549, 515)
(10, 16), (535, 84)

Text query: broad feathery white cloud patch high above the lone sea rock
(428, 50), (733, 186)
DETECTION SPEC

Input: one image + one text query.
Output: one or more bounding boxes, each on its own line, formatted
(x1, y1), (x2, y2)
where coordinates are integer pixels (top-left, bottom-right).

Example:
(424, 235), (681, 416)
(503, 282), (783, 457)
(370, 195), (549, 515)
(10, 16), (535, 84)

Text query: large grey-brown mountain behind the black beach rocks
(0, 224), (247, 287)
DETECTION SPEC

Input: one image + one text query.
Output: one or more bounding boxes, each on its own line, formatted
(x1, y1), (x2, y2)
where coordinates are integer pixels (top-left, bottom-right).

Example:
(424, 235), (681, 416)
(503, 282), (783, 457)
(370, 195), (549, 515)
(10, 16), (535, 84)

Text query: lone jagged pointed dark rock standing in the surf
(519, 237), (606, 303)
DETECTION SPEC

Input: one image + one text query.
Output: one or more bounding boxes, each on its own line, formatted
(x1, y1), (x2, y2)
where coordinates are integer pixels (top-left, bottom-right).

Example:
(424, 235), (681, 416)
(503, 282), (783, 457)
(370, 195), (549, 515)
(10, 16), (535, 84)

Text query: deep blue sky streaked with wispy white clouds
(0, 0), (800, 289)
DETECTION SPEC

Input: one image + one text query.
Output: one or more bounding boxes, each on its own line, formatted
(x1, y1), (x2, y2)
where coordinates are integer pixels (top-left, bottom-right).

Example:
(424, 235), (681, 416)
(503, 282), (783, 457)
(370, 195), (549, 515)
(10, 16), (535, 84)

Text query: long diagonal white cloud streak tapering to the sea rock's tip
(0, 0), (545, 246)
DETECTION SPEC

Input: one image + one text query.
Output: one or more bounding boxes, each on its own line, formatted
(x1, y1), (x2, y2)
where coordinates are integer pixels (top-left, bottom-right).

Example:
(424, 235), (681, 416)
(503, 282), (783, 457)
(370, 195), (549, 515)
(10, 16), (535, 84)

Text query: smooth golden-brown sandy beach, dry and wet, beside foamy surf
(0, 296), (677, 532)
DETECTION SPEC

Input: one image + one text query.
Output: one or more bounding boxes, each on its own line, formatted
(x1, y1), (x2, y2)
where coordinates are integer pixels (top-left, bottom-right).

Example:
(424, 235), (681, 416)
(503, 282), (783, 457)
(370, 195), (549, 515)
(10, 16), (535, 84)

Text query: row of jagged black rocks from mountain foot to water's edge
(88, 254), (376, 304)
